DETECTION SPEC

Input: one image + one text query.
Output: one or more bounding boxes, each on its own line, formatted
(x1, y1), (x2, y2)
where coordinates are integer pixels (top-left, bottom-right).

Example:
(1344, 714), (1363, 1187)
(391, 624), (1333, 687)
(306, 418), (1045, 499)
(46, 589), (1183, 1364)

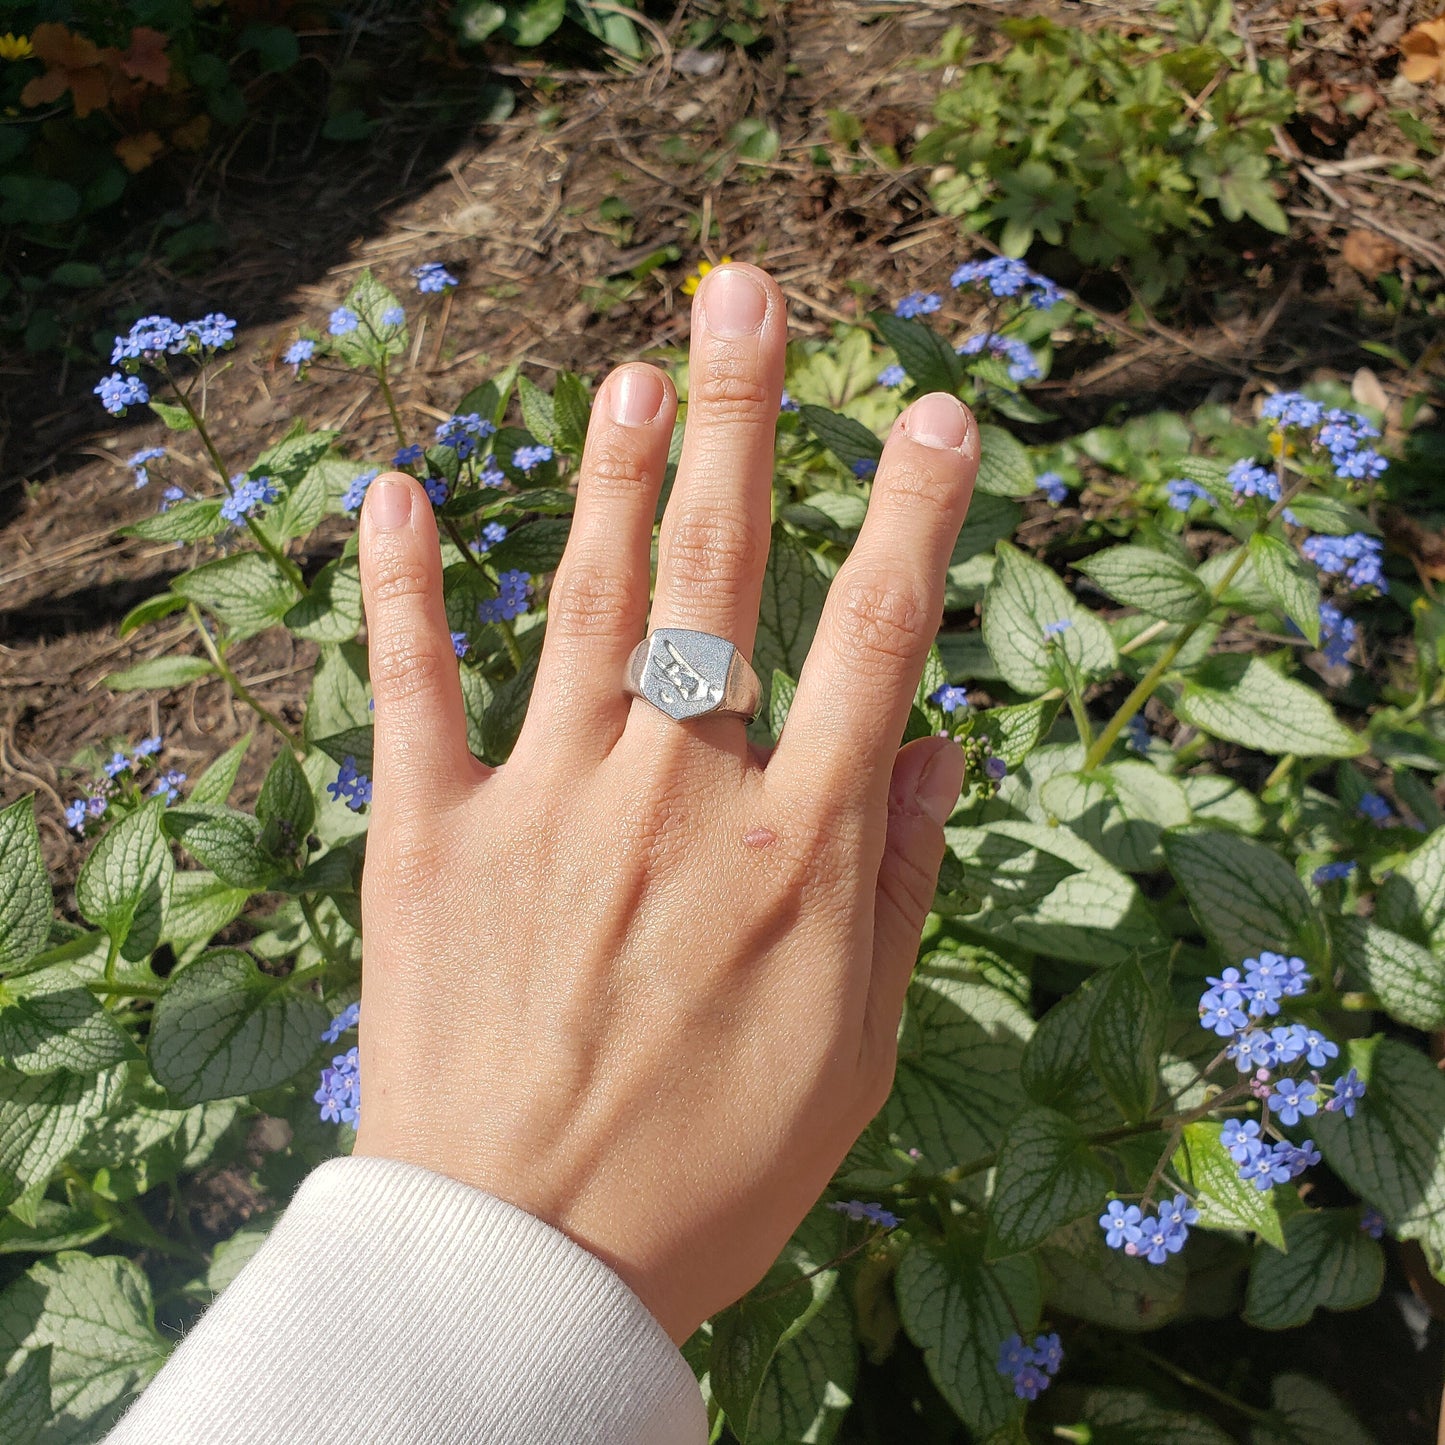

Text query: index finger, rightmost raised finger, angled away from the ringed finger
(767, 392), (978, 805)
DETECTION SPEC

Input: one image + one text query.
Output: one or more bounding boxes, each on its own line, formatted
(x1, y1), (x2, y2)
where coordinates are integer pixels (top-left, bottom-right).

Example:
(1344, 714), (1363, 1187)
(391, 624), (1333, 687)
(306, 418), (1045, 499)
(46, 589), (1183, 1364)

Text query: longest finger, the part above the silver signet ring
(649, 264), (788, 657)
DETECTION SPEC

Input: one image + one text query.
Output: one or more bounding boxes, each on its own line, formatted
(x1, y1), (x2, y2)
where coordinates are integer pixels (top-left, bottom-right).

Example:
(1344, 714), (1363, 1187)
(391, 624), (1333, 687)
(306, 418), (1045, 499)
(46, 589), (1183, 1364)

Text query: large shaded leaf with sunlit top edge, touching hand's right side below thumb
(880, 967), (1033, 1169)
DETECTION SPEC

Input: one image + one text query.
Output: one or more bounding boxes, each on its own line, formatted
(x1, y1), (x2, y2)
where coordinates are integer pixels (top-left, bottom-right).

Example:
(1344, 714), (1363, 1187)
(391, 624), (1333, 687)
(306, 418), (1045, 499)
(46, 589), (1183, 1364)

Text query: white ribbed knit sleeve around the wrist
(105, 1157), (708, 1445)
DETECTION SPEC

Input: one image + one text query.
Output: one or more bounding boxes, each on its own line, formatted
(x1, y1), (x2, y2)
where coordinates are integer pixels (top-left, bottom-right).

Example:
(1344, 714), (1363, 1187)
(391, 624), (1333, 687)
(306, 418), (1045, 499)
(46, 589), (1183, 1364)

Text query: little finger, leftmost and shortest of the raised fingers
(360, 473), (475, 808)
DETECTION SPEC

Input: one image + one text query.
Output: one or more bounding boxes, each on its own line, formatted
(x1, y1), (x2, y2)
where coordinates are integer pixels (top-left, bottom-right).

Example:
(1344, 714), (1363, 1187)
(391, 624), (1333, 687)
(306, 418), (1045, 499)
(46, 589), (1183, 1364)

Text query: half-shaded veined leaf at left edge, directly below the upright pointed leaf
(0, 964), (139, 1074)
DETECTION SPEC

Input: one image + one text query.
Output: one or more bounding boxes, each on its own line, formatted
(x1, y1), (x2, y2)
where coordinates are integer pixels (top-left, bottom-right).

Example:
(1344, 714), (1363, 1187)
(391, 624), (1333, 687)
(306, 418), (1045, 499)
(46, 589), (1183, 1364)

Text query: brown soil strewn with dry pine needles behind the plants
(0, 0), (1445, 874)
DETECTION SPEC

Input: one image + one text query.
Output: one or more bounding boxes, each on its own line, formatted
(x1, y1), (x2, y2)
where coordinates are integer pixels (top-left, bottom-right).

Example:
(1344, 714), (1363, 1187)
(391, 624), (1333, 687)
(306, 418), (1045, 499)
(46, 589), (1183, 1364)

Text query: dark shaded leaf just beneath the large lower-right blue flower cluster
(1038, 1219), (1189, 1334)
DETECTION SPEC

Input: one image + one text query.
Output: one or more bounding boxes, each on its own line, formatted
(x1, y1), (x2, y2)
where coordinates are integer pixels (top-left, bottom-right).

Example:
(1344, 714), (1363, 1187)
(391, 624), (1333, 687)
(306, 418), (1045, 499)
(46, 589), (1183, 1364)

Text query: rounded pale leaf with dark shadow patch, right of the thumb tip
(1039, 759), (1191, 873)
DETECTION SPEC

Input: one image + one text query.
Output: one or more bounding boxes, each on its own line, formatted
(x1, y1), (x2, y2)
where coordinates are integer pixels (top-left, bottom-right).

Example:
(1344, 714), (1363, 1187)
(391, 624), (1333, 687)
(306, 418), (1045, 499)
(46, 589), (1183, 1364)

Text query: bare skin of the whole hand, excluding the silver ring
(355, 264), (978, 1342)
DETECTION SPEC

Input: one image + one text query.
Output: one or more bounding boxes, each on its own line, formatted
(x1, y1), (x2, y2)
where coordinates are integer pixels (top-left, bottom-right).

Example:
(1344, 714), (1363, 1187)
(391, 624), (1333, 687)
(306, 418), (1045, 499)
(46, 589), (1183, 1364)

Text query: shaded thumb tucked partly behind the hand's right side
(868, 737), (964, 1046)
